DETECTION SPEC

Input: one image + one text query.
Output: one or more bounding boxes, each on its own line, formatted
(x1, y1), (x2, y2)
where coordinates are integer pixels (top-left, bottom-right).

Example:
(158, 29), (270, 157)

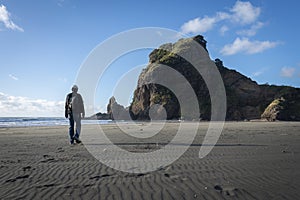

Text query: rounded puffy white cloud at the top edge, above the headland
(230, 1), (261, 24)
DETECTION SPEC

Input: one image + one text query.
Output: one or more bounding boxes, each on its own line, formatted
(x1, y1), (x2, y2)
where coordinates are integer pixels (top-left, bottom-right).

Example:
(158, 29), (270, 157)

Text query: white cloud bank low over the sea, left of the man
(0, 92), (64, 117)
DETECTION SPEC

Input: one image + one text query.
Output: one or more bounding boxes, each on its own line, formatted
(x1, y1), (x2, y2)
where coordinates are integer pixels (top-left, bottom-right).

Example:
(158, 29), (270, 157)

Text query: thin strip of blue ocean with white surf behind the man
(0, 117), (112, 128)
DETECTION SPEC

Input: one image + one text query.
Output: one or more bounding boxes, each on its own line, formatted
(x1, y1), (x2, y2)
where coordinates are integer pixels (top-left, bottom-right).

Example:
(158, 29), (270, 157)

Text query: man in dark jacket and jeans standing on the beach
(65, 85), (85, 144)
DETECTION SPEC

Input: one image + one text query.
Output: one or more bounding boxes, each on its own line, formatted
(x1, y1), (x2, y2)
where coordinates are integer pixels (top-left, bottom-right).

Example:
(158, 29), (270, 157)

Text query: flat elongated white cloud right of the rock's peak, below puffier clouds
(221, 38), (279, 55)
